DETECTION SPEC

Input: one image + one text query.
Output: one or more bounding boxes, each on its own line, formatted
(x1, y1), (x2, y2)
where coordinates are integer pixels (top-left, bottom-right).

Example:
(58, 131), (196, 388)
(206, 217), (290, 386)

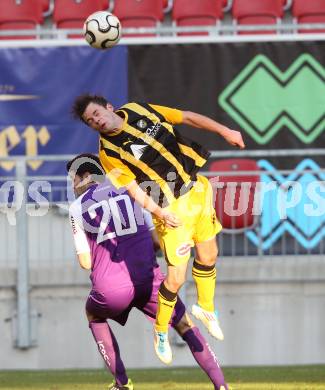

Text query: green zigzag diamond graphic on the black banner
(219, 54), (325, 144)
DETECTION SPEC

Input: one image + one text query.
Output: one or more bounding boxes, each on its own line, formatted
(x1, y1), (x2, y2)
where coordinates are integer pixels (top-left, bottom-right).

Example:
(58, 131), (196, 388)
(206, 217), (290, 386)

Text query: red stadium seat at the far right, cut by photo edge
(292, 0), (325, 33)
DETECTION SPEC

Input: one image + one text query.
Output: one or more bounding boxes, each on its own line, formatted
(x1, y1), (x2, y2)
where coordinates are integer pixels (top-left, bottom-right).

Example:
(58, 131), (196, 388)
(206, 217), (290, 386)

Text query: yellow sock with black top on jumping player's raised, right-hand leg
(192, 260), (217, 311)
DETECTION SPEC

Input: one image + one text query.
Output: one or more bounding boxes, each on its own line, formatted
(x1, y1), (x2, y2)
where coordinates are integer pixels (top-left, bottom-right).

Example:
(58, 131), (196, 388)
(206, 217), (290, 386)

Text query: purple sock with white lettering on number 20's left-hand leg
(89, 320), (128, 385)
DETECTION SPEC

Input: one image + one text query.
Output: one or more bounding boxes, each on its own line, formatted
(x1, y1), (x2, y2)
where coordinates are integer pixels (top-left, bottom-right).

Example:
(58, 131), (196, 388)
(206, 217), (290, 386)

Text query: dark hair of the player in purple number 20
(66, 153), (105, 176)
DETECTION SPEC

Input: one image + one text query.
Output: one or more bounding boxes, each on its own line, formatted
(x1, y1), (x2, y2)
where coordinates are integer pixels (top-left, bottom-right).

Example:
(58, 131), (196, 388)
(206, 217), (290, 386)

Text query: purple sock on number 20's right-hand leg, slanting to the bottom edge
(183, 327), (228, 390)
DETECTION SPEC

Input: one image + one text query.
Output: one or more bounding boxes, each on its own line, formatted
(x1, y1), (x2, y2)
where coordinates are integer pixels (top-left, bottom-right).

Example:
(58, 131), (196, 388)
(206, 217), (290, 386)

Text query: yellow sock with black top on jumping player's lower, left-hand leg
(155, 283), (177, 332)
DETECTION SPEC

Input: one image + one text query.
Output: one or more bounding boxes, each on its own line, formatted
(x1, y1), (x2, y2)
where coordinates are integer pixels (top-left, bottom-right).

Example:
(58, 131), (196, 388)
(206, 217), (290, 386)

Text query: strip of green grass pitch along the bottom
(0, 366), (325, 390)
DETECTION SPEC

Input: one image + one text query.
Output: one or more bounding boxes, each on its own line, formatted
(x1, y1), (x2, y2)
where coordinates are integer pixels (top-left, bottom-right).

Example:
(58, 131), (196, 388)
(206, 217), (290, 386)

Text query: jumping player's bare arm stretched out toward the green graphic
(182, 111), (245, 149)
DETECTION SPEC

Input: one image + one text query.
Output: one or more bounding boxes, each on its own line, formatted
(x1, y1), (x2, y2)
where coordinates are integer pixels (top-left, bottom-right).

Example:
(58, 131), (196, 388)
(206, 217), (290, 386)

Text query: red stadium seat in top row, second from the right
(232, 0), (284, 34)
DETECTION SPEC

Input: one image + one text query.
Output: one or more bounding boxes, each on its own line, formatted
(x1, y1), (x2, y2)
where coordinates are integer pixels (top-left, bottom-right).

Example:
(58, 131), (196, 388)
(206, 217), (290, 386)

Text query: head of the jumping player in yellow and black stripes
(72, 94), (119, 134)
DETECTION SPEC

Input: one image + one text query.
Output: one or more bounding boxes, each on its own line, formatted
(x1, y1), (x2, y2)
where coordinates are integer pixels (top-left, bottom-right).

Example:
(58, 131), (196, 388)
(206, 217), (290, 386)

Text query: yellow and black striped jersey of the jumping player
(99, 102), (209, 206)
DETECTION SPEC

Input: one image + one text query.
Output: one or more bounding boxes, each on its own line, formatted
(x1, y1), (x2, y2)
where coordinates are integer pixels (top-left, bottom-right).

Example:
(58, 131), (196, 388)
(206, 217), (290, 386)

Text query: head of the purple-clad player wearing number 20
(66, 153), (105, 196)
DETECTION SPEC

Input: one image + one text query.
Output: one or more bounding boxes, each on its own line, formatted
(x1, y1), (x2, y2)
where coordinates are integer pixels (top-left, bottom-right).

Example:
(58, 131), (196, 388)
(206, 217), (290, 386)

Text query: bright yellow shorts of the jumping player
(154, 176), (222, 265)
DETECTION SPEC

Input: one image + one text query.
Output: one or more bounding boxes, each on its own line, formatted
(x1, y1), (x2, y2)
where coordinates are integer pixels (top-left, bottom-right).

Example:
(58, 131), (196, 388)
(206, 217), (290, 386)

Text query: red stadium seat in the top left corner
(0, 0), (44, 39)
